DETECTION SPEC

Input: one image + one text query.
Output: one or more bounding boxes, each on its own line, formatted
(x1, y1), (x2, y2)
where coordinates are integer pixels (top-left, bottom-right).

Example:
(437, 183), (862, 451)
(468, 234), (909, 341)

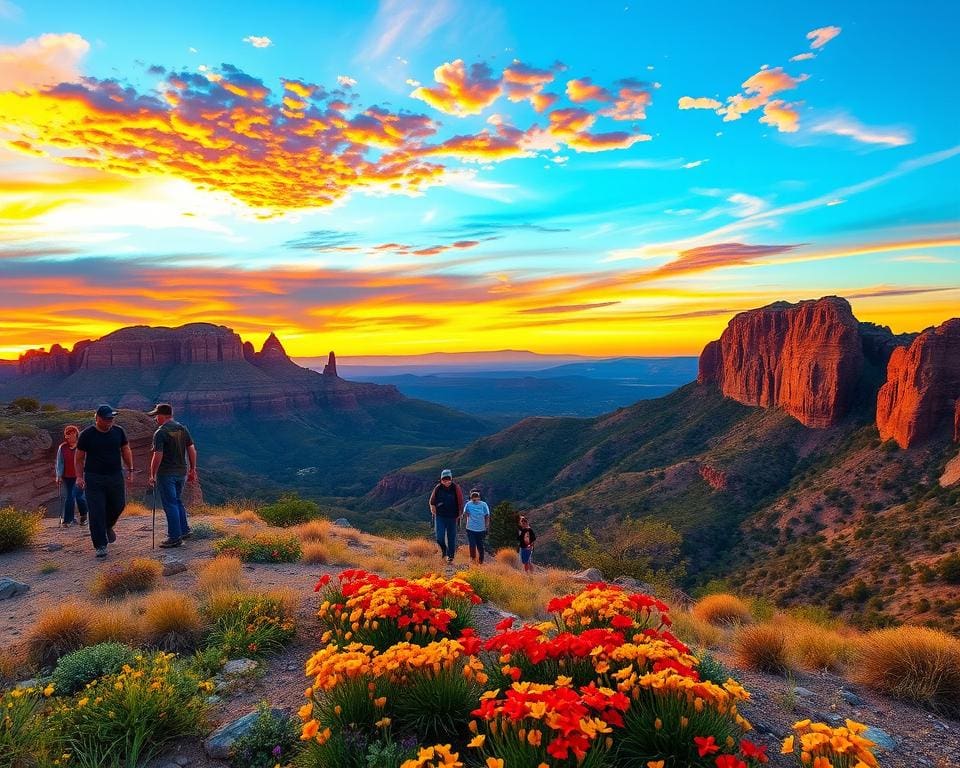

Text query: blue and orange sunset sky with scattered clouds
(0, 0), (960, 358)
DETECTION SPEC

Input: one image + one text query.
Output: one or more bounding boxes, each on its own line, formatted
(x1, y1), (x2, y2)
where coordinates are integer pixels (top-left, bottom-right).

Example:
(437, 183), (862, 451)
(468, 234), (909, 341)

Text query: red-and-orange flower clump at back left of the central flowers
(315, 570), (480, 650)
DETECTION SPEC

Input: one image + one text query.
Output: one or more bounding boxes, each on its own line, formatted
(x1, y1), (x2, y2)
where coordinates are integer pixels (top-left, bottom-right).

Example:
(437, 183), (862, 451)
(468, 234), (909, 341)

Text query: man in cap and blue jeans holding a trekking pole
(147, 403), (197, 549)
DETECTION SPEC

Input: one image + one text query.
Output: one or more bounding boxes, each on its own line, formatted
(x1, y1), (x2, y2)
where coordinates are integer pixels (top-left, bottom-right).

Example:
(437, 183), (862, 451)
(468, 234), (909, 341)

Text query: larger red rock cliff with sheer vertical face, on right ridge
(697, 296), (864, 428)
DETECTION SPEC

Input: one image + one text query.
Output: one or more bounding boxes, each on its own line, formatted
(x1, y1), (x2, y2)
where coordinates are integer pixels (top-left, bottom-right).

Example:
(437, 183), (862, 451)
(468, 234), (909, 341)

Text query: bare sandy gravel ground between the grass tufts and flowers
(0, 515), (960, 768)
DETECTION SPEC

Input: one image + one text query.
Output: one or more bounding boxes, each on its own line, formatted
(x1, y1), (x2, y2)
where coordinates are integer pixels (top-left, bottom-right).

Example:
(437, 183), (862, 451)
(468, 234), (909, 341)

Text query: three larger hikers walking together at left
(54, 403), (197, 557)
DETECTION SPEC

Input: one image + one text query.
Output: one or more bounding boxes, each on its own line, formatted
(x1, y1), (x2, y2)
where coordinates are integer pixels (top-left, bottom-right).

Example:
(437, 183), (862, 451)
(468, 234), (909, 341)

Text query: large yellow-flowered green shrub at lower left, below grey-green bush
(50, 652), (213, 766)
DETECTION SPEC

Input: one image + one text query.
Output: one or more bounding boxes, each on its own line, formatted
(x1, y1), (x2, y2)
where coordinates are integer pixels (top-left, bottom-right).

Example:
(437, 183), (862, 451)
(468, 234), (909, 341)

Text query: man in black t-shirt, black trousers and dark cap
(76, 405), (133, 557)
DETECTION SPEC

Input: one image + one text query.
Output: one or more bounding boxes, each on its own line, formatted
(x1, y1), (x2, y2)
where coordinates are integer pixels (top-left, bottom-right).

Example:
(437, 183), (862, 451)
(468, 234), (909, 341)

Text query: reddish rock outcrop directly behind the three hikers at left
(0, 411), (157, 517)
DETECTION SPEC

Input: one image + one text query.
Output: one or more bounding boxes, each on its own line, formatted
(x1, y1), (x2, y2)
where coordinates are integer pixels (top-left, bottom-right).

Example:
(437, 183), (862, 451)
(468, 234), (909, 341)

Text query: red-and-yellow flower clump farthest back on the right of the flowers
(547, 582), (670, 633)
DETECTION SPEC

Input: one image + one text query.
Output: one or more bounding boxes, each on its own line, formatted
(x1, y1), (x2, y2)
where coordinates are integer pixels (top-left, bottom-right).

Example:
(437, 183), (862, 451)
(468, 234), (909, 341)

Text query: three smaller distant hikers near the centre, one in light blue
(429, 469), (537, 573)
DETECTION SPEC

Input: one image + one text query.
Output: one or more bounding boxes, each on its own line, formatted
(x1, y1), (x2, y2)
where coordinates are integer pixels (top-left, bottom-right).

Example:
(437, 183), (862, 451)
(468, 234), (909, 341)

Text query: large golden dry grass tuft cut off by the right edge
(854, 626), (960, 717)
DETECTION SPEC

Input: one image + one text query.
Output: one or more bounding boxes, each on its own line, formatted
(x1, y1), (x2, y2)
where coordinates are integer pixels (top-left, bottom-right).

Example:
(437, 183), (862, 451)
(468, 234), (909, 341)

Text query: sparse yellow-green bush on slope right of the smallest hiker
(558, 519), (686, 584)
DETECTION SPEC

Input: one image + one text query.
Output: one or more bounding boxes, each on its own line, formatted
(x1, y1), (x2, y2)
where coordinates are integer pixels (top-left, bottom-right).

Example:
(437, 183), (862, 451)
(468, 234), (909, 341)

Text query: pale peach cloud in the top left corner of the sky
(0, 32), (90, 91)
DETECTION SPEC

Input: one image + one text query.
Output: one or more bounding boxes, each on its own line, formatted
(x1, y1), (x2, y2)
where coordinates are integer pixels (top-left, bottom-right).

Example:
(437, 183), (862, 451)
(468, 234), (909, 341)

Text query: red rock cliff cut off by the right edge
(877, 317), (960, 448)
